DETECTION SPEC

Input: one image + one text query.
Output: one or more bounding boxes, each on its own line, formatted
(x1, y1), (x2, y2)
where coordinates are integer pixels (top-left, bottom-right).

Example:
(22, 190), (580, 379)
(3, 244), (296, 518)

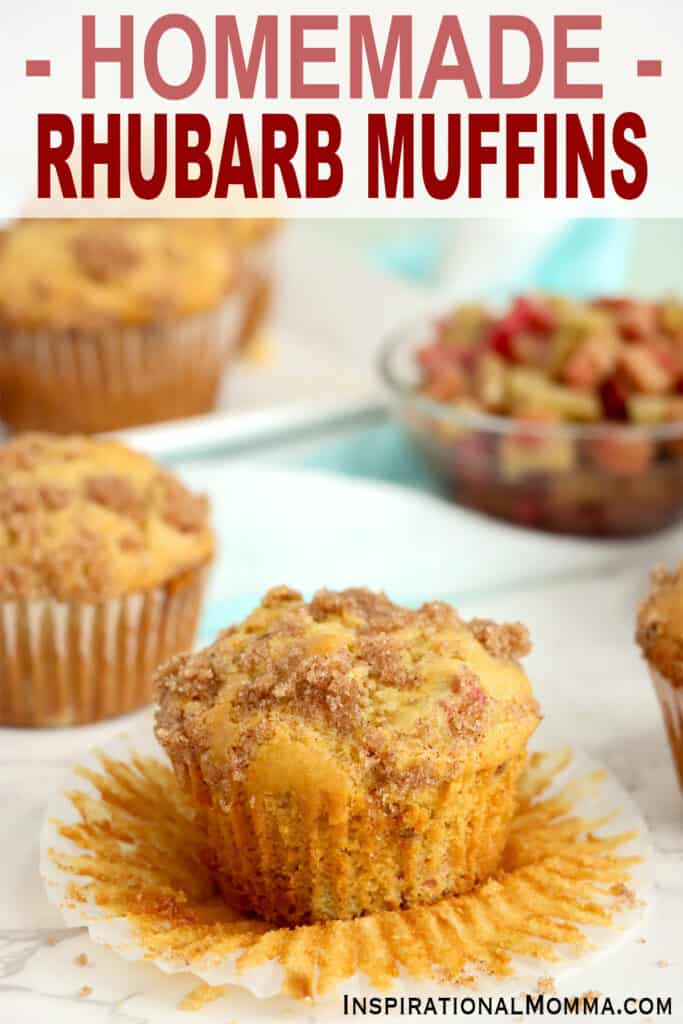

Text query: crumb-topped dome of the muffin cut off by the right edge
(637, 562), (683, 686)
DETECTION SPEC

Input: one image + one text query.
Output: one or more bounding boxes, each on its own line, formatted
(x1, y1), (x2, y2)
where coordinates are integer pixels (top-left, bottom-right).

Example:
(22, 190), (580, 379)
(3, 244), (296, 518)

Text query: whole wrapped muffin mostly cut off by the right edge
(637, 563), (683, 787)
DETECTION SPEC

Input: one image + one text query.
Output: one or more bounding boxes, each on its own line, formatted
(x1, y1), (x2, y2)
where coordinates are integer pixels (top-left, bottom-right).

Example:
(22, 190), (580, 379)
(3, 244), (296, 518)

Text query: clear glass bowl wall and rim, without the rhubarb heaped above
(380, 316), (683, 537)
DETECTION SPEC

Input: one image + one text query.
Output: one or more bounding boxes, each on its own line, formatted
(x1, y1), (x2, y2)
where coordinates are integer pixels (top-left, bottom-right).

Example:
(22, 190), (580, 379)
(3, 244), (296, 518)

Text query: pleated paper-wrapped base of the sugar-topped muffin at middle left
(0, 563), (207, 726)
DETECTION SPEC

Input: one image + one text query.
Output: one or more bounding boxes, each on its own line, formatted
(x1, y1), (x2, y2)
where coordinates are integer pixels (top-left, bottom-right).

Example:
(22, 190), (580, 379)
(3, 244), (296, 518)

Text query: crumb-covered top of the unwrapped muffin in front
(157, 587), (539, 801)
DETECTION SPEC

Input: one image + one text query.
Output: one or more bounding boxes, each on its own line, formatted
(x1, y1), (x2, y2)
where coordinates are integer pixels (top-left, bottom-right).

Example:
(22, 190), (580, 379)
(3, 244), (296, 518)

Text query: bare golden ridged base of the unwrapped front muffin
(181, 752), (525, 925)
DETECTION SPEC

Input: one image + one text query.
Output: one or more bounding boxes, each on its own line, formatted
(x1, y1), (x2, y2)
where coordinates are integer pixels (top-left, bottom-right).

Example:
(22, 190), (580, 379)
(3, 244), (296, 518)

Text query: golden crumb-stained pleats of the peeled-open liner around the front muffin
(46, 752), (639, 1003)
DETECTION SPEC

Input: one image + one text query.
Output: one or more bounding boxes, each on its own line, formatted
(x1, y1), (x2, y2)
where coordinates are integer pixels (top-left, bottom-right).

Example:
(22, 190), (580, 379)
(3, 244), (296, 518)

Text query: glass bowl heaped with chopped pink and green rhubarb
(380, 295), (683, 537)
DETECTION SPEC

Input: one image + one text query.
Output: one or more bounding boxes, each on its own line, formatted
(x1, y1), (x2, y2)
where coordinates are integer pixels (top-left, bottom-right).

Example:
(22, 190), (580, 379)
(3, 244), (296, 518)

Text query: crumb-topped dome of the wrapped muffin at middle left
(0, 434), (213, 601)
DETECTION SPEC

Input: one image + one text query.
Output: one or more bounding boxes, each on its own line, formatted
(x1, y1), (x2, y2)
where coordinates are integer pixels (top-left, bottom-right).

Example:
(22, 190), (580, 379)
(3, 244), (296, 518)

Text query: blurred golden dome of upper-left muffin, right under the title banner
(0, 219), (237, 330)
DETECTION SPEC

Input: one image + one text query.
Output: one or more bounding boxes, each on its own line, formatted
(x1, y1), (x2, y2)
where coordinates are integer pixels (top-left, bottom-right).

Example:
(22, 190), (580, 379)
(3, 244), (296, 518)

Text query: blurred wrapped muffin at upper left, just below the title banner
(0, 219), (246, 433)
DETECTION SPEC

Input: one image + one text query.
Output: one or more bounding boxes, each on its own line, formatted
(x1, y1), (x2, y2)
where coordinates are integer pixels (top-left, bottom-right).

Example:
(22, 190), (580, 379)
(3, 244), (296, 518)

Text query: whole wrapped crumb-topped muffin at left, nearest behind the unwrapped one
(0, 434), (213, 725)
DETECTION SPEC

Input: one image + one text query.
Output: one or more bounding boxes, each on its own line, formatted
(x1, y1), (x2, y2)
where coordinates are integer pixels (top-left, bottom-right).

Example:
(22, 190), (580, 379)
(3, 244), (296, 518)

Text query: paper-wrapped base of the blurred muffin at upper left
(0, 292), (244, 433)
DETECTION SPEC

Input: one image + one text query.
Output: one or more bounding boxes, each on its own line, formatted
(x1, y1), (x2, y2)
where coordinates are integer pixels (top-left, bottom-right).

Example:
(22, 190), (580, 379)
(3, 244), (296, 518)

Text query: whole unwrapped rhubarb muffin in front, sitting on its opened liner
(157, 587), (539, 924)
